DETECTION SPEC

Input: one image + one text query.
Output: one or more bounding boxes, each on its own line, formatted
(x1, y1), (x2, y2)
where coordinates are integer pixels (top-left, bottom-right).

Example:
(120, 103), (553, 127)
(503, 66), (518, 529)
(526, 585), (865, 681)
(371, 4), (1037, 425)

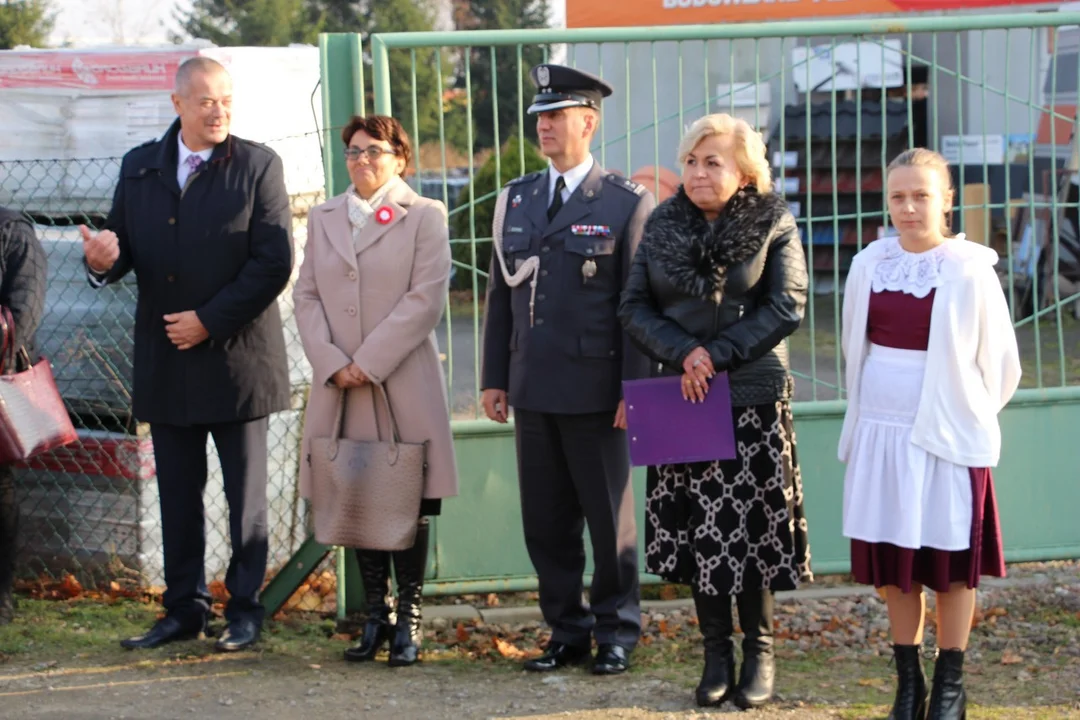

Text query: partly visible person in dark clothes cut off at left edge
(0, 207), (46, 625)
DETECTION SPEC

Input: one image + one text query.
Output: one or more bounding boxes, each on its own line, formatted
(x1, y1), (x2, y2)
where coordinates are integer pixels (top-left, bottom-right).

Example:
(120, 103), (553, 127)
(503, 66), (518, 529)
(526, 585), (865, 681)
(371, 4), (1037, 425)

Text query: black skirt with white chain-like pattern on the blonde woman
(645, 402), (813, 595)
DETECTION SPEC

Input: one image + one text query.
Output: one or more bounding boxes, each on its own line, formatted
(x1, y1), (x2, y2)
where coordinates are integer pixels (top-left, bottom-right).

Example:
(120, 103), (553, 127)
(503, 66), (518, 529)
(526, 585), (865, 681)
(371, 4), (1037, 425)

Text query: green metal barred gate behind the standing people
(261, 13), (1080, 613)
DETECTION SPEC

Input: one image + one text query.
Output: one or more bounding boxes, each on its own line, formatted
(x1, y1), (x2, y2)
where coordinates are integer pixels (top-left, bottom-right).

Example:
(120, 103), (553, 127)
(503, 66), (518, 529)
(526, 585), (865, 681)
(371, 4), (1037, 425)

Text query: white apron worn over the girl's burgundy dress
(843, 344), (972, 551)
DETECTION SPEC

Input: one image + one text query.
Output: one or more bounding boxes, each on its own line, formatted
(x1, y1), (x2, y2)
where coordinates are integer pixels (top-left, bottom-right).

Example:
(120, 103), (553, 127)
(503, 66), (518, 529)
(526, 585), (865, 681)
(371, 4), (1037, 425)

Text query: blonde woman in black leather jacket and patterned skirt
(619, 114), (812, 709)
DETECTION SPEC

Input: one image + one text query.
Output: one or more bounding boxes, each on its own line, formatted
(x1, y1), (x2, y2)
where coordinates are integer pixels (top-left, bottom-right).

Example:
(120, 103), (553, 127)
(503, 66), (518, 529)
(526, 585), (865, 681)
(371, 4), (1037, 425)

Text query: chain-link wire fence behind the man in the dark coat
(0, 133), (324, 588)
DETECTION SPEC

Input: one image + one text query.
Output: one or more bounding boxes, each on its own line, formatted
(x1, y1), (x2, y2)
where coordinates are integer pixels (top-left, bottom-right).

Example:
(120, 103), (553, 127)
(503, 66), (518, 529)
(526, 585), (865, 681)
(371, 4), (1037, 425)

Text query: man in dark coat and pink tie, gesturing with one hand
(82, 57), (293, 651)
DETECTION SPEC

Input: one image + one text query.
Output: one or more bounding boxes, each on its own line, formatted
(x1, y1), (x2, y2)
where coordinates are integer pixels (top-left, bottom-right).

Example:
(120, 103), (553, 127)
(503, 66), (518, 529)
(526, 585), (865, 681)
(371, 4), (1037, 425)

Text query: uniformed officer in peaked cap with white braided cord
(482, 64), (656, 675)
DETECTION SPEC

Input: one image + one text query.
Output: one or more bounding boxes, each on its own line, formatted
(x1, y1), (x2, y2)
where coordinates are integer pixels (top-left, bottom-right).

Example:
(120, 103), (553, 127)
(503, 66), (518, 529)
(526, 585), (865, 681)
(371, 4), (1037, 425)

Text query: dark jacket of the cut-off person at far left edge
(0, 207), (48, 360)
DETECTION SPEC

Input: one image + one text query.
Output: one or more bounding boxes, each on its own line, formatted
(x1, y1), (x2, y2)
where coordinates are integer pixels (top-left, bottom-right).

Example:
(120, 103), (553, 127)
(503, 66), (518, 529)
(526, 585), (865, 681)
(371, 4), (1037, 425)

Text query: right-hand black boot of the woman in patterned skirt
(734, 589), (777, 710)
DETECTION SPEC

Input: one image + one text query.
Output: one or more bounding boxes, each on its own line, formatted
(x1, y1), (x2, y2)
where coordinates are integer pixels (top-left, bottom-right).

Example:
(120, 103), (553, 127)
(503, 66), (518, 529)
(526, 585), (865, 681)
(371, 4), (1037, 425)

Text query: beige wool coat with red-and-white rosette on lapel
(293, 182), (458, 505)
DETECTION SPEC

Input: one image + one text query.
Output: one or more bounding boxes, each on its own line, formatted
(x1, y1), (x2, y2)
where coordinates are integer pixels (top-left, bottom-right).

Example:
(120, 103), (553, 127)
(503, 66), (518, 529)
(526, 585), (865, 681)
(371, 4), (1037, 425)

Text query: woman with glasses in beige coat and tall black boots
(293, 116), (458, 666)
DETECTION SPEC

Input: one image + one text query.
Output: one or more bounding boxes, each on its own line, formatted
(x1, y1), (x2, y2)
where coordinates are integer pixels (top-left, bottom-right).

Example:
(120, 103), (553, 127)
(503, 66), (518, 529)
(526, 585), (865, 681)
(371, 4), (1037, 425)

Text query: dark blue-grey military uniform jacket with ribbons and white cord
(482, 162), (656, 415)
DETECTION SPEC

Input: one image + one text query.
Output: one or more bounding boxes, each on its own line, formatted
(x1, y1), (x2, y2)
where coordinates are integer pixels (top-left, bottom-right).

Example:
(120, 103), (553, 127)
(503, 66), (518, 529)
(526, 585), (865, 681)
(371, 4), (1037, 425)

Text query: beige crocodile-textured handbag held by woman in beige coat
(310, 383), (428, 551)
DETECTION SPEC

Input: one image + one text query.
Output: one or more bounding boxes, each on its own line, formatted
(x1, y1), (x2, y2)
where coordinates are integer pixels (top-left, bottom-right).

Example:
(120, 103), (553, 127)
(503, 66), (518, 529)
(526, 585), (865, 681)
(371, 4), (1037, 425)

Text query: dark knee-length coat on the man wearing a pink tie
(93, 120), (293, 425)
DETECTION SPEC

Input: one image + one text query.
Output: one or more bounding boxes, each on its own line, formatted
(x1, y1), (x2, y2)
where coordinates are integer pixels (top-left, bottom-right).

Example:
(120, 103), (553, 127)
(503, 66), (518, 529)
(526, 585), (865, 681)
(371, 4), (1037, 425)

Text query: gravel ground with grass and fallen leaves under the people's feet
(0, 563), (1080, 720)
